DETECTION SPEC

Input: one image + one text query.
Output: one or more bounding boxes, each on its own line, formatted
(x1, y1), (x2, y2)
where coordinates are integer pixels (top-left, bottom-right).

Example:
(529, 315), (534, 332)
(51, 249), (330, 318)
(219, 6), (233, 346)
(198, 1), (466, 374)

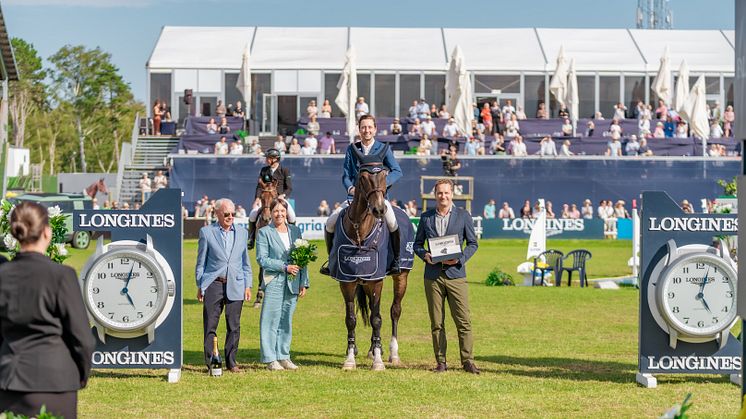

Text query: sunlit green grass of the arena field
(61, 240), (740, 418)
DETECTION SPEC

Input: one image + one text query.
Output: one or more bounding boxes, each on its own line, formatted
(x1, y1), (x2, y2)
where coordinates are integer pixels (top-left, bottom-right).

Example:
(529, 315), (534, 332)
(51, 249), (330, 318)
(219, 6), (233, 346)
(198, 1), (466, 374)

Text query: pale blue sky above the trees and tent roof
(0, 0), (735, 100)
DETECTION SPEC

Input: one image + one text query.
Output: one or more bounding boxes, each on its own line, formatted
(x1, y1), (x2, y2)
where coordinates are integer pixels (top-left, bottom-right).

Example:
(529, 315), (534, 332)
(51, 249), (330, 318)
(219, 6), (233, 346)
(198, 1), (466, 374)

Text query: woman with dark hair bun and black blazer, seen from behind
(0, 202), (95, 418)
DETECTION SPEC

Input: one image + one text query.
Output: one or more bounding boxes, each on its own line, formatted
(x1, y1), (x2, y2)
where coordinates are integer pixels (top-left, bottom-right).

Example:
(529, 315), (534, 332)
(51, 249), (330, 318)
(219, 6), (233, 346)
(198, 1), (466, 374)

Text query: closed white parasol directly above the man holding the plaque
(445, 45), (474, 138)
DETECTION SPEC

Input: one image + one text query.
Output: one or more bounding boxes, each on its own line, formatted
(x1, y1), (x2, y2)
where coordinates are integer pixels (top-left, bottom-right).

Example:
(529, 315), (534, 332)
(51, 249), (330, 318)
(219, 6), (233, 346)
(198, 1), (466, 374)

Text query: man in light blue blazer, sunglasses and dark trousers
(195, 198), (252, 372)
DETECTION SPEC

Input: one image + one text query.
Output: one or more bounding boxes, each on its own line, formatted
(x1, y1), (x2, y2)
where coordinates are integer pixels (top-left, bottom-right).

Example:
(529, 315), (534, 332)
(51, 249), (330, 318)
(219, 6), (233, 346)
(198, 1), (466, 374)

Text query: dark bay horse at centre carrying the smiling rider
(330, 162), (414, 371)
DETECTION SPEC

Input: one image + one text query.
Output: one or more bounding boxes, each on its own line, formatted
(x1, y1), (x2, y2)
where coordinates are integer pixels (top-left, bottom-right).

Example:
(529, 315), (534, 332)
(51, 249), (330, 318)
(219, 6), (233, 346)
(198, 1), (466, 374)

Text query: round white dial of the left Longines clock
(85, 250), (168, 331)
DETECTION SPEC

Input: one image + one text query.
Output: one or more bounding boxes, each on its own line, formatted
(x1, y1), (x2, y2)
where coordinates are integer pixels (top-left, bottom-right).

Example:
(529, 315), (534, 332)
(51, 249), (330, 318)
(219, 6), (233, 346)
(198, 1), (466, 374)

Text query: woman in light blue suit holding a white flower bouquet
(256, 199), (309, 371)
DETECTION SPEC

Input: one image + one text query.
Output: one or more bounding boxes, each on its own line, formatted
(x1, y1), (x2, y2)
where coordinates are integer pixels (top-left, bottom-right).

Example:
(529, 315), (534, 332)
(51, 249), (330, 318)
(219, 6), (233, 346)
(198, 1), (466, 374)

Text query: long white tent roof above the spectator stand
(147, 26), (735, 74)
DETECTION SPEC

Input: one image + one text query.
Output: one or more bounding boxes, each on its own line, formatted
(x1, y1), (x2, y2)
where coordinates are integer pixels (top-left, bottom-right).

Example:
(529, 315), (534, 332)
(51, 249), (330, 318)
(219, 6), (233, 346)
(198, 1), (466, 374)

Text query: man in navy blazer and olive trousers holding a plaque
(414, 179), (479, 374)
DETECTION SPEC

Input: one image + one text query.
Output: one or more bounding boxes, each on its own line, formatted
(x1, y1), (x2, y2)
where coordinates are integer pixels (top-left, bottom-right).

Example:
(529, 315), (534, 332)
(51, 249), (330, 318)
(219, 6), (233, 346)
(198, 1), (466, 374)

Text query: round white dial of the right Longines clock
(658, 254), (736, 336)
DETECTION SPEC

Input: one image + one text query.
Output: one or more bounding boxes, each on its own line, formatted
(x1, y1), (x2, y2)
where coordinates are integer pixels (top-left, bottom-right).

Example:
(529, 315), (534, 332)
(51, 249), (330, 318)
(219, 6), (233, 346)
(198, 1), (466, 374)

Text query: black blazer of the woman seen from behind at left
(0, 252), (96, 392)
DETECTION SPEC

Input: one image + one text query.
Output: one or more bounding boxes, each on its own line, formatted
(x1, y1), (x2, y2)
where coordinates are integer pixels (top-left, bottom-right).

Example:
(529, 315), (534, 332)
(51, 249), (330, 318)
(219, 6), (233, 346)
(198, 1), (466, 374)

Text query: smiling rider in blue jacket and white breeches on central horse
(321, 115), (402, 275)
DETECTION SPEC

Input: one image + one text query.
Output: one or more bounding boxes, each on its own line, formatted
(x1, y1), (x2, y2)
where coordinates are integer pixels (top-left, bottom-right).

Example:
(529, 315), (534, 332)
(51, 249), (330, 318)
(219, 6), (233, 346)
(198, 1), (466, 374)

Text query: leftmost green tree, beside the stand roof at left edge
(8, 38), (48, 147)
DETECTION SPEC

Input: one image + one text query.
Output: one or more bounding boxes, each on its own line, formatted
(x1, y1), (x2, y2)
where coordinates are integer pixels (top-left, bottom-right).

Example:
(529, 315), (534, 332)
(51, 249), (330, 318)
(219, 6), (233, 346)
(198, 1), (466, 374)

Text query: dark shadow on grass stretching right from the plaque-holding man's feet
(475, 355), (728, 383)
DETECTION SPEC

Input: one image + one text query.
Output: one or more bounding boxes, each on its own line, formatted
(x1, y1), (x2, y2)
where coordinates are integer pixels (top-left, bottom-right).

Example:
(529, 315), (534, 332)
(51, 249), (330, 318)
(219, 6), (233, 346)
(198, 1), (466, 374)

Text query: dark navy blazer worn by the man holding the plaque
(414, 206), (479, 279)
